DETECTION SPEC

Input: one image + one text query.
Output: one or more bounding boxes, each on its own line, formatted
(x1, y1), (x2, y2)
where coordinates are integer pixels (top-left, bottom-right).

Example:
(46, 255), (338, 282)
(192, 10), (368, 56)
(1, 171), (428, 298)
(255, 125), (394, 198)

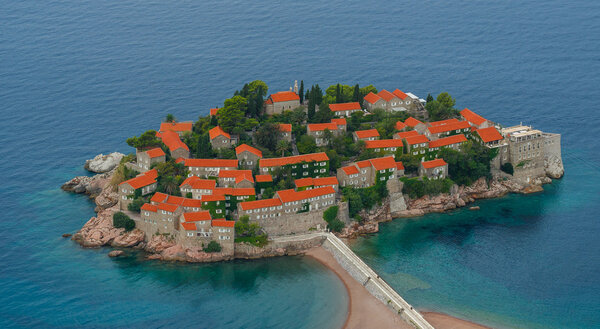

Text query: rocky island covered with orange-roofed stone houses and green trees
(63, 80), (564, 262)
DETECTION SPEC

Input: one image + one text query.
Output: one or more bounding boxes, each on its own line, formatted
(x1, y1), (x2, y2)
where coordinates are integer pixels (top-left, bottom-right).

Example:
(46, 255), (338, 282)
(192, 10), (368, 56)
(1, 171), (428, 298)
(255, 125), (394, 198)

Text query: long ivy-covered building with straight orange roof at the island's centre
(259, 152), (329, 178)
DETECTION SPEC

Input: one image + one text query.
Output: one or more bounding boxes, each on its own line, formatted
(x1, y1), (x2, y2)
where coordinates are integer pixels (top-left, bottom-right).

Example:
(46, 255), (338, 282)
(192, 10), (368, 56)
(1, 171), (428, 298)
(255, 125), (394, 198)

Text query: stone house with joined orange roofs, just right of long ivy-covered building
(337, 156), (397, 188)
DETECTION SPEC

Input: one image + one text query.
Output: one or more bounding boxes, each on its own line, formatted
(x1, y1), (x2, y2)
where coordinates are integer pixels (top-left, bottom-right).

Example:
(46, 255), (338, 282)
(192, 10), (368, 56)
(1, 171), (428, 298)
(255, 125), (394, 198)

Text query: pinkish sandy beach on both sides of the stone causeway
(306, 247), (490, 329)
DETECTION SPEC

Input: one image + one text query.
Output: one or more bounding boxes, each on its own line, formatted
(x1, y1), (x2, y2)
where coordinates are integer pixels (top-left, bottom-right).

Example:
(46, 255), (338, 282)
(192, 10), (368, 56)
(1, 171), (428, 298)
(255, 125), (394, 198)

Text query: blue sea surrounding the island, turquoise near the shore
(0, 0), (600, 328)
